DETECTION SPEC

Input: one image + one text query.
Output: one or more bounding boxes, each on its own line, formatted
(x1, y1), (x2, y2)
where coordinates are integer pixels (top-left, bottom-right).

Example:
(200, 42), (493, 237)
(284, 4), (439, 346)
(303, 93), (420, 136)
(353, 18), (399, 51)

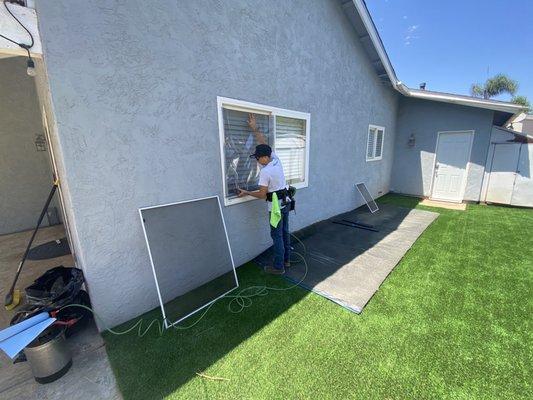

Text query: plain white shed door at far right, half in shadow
(486, 143), (520, 204)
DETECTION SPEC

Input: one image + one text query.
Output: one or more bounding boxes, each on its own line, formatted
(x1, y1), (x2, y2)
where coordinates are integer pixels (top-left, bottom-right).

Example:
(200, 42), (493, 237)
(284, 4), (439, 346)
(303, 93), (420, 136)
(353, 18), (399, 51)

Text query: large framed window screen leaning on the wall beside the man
(140, 197), (238, 327)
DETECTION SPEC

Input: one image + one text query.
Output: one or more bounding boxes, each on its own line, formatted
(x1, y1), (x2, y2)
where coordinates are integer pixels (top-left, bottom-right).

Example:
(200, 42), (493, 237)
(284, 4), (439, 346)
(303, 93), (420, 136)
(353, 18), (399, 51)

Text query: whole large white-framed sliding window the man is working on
(218, 97), (310, 205)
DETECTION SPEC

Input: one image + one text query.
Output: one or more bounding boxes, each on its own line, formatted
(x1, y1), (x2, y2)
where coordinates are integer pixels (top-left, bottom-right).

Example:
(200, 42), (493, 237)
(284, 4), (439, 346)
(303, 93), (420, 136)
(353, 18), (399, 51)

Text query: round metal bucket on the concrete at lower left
(24, 327), (72, 383)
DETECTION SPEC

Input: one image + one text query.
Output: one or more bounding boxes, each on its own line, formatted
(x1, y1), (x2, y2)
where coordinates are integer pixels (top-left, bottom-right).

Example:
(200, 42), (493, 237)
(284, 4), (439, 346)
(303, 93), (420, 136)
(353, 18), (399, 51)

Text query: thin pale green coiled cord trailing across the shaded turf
(58, 233), (308, 338)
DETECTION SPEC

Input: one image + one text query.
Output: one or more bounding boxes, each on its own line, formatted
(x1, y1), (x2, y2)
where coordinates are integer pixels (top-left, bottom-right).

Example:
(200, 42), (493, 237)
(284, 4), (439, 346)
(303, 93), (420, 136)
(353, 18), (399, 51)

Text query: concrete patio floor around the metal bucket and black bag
(0, 225), (121, 400)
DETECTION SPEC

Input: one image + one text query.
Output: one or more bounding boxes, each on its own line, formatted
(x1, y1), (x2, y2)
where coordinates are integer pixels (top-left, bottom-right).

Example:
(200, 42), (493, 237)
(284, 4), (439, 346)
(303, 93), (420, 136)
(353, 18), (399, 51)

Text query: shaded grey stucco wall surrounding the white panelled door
(391, 97), (493, 201)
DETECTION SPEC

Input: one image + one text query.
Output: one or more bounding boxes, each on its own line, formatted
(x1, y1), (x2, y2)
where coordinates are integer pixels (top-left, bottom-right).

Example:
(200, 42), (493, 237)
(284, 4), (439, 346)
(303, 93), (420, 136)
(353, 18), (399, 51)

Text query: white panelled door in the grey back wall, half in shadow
(431, 131), (474, 202)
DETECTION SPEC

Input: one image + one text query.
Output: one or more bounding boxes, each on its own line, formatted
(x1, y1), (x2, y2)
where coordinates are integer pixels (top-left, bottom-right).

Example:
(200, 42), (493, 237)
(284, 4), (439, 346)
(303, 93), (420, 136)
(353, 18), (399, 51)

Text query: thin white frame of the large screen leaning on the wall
(139, 196), (239, 329)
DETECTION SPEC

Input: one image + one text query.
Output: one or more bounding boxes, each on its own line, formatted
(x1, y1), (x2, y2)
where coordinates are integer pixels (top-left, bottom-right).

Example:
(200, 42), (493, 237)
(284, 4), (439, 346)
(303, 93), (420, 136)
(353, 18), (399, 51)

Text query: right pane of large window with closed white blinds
(275, 116), (306, 185)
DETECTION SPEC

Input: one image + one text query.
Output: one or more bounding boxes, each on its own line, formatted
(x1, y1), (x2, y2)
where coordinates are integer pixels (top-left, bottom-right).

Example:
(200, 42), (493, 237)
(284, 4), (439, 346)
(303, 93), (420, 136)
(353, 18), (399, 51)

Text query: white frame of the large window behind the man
(217, 96), (311, 206)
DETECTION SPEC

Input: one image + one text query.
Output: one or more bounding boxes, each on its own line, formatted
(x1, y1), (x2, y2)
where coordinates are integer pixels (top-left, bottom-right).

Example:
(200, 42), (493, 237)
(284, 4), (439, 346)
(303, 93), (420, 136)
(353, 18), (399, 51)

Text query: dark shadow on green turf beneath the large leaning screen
(103, 263), (309, 400)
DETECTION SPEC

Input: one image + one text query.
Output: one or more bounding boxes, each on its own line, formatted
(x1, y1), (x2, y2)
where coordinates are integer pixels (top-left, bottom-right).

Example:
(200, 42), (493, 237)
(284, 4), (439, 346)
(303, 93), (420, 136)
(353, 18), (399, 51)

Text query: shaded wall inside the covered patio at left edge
(0, 57), (59, 235)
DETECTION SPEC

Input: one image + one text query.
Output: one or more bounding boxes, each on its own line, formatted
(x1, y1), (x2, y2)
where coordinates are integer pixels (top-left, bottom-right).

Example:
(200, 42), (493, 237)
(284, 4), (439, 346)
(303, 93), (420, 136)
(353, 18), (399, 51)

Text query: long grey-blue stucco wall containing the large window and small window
(37, 0), (398, 325)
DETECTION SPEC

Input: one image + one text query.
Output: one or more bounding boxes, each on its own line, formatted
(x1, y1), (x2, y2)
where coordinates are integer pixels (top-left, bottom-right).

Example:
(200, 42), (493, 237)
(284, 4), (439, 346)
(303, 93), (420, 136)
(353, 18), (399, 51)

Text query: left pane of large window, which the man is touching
(222, 108), (271, 198)
